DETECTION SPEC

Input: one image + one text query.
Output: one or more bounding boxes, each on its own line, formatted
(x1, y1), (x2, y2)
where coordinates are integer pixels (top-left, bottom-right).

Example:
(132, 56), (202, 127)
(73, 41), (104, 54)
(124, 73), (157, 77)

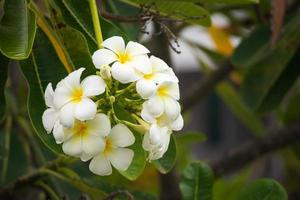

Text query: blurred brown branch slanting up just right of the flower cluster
(182, 61), (233, 112)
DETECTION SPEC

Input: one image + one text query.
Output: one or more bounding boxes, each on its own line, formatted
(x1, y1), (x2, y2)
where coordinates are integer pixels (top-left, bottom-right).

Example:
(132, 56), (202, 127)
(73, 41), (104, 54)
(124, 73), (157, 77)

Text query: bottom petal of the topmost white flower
(111, 62), (139, 83)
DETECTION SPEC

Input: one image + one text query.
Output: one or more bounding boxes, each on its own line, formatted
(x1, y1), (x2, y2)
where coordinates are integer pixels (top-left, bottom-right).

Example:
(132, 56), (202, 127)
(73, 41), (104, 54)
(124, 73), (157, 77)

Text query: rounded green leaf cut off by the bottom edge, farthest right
(236, 179), (288, 200)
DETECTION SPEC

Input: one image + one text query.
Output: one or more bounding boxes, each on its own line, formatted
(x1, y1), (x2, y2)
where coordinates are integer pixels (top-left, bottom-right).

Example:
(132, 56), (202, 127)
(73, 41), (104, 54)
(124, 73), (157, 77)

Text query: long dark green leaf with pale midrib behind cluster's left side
(21, 29), (67, 154)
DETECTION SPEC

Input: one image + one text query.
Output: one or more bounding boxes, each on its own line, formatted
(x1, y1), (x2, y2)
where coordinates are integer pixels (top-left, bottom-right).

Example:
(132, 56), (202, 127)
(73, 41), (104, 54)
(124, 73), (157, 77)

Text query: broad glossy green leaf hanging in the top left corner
(0, 0), (36, 60)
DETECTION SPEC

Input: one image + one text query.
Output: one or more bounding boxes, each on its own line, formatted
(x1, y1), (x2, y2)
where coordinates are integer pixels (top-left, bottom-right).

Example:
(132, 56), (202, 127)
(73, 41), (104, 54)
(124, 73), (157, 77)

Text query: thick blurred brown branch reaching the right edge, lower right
(210, 124), (300, 177)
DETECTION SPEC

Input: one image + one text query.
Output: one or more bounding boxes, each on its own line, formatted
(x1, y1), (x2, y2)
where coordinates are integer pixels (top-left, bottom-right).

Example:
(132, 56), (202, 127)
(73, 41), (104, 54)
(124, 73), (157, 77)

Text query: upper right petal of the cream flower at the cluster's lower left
(86, 113), (111, 136)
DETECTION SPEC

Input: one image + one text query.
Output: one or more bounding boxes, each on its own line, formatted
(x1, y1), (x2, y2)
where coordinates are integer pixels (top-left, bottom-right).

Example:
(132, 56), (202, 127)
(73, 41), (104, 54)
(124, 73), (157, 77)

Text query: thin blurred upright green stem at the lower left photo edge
(1, 116), (12, 183)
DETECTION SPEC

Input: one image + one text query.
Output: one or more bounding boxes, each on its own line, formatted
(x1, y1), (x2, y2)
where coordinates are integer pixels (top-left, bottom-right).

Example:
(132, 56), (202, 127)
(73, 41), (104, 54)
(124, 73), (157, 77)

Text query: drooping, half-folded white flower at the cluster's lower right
(143, 124), (172, 161)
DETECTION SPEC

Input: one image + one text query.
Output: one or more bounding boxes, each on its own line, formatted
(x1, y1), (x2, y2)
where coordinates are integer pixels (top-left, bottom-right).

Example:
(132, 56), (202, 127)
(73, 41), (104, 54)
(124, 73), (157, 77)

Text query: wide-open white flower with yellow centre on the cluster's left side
(53, 68), (105, 127)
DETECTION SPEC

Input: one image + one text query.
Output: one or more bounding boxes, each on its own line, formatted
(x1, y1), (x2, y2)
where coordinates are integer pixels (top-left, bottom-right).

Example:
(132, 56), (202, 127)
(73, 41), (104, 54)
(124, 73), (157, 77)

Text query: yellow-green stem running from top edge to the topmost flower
(89, 0), (103, 48)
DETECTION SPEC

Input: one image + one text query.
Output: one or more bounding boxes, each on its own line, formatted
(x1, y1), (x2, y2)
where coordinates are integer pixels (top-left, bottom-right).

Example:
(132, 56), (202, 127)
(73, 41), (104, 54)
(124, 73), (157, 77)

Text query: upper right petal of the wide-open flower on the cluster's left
(81, 75), (105, 96)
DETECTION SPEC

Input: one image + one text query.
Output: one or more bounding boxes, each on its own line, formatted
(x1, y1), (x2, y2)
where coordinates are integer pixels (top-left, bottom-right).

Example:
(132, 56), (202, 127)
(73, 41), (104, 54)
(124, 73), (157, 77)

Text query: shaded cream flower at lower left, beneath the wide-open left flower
(61, 113), (111, 161)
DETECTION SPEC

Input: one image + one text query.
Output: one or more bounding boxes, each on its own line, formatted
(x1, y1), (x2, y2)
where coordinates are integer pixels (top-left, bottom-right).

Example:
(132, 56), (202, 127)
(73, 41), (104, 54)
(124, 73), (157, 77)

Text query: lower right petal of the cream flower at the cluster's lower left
(82, 134), (105, 156)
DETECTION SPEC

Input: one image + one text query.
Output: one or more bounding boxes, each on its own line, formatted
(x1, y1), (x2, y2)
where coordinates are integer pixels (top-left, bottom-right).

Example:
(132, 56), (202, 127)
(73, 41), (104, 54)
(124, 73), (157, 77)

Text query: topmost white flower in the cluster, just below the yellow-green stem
(92, 36), (151, 83)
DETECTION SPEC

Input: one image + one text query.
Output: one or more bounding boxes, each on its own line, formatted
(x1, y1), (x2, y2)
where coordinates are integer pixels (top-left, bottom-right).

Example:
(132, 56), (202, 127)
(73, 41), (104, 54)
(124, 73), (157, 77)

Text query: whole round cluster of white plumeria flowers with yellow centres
(42, 36), (183, 175)
